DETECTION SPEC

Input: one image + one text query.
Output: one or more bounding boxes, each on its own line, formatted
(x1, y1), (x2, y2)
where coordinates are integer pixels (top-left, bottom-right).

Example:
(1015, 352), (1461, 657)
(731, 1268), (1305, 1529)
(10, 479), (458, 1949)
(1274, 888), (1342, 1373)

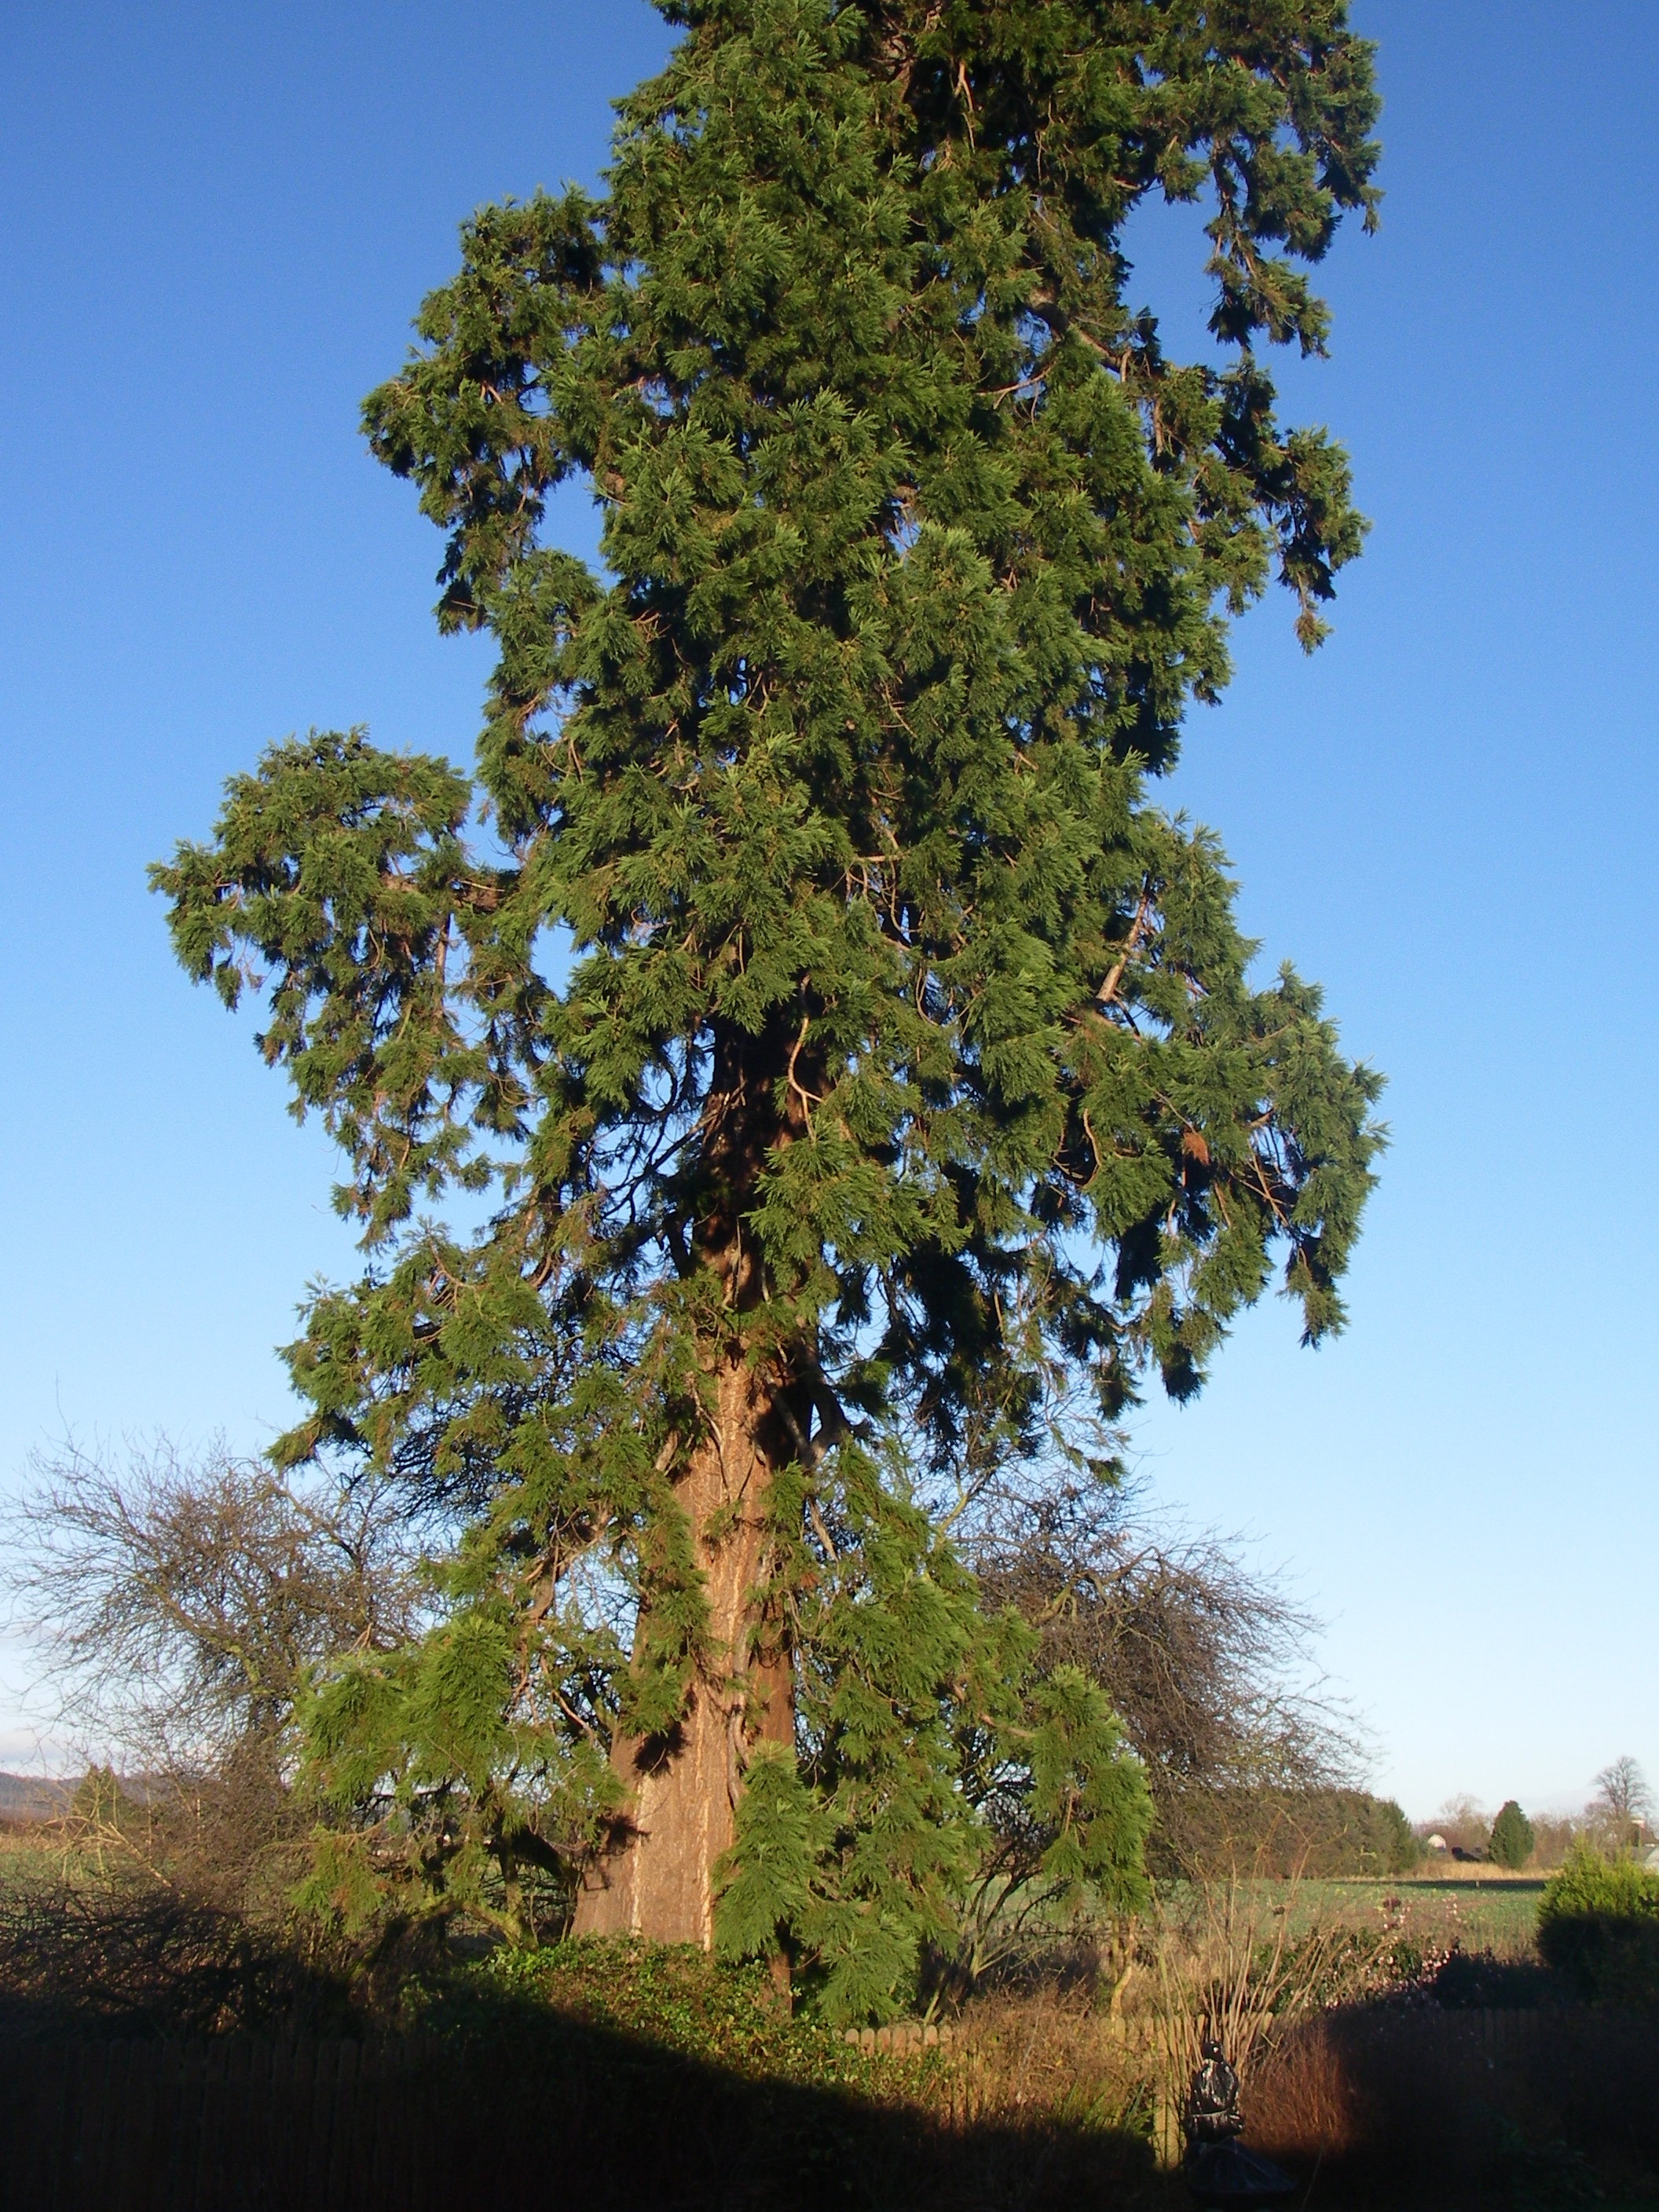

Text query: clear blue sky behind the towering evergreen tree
(0, 0), (1659, 1814)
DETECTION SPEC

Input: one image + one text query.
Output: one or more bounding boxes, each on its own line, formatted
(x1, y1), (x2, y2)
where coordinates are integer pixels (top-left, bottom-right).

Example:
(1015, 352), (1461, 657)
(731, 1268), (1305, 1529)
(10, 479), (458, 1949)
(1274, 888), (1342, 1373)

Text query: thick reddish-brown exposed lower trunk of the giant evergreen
(575, 1363), (794, 1949)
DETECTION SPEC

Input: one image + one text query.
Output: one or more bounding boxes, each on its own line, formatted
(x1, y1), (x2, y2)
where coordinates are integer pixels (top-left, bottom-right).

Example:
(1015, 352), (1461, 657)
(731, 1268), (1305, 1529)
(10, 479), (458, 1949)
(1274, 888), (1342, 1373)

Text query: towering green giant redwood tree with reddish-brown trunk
(155, 0), (1378, 2013)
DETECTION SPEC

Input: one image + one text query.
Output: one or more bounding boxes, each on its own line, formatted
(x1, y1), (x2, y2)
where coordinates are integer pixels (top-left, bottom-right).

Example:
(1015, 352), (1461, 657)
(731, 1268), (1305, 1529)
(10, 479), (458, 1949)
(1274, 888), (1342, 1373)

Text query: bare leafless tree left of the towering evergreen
(0, 1445), (418, 2033)
